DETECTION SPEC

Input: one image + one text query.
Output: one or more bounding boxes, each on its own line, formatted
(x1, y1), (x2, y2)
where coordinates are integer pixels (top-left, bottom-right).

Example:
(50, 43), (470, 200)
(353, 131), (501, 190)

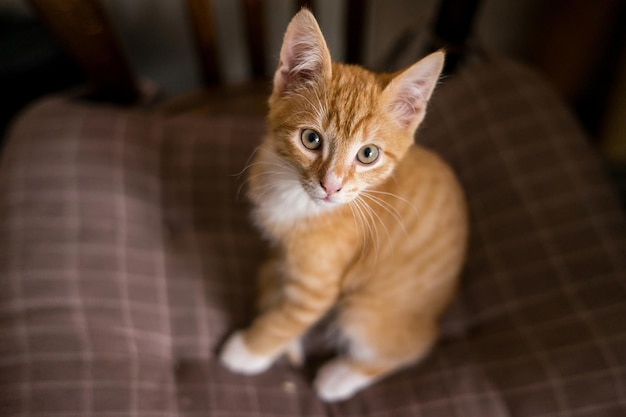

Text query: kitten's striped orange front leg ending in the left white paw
(220, 236), (346, 374)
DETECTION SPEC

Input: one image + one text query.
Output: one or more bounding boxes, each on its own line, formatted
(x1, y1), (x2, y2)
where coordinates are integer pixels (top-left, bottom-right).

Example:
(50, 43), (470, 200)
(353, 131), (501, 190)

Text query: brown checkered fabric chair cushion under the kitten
(0, 60), (626, 417)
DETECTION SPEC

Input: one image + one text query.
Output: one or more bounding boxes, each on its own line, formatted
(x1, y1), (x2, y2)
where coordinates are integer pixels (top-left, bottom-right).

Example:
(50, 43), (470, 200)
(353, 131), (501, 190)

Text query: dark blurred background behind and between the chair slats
(0, 0), (626, 202)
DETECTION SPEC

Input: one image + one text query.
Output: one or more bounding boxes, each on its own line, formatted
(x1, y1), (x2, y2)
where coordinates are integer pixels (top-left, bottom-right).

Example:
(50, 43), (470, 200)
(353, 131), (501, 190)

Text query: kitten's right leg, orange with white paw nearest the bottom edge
(314, 314), (437, 402)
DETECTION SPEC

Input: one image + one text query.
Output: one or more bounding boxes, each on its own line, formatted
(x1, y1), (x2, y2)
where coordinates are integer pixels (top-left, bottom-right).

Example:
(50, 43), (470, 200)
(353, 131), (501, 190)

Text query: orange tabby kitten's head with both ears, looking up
(260, 10), (444, 210)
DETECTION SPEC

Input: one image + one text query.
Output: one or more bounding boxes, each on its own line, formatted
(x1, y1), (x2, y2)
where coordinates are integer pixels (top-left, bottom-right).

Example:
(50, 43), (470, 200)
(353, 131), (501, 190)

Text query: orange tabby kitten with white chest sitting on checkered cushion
(220, 10), (467, 401)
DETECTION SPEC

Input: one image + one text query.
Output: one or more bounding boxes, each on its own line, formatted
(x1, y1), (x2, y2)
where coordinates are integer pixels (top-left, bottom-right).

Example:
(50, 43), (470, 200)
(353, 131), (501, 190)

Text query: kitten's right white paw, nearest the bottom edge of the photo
(315, 359), (374, 402)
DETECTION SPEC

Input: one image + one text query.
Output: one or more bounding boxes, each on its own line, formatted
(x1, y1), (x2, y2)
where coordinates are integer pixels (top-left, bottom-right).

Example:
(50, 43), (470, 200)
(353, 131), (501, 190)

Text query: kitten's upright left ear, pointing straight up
(274, 9), (332, 95)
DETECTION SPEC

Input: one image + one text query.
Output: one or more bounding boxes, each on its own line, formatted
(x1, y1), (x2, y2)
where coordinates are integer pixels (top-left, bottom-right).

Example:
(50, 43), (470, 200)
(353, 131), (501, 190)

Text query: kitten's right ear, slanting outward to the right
(383, 51), (445, 129)
